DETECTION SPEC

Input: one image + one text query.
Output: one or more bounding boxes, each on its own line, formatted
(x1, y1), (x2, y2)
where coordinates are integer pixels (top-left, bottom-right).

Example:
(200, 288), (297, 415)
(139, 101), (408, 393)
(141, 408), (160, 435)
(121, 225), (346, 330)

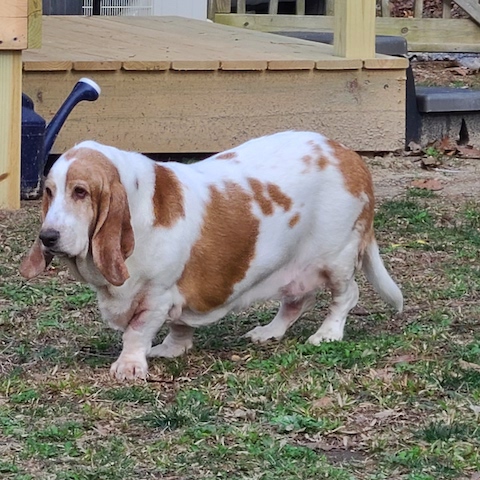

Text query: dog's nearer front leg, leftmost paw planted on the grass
(110, 310), (168, 380)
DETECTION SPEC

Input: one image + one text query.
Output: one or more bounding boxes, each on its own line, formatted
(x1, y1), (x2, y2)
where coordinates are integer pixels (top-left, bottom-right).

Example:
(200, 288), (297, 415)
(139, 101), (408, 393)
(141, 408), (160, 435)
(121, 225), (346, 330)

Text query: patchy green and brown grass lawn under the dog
(0, 185), (480, 480)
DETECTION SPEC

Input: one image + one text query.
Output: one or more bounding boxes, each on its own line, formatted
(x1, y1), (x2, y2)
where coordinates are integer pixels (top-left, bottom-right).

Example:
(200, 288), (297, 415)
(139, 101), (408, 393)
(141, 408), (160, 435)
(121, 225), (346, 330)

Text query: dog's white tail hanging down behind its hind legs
(362, 239), (403, 312)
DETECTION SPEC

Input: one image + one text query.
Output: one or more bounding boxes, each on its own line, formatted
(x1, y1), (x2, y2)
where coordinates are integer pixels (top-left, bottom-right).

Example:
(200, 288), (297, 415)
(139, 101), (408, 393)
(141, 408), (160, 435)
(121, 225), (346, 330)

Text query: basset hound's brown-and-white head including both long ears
(20, 147), (134, 286)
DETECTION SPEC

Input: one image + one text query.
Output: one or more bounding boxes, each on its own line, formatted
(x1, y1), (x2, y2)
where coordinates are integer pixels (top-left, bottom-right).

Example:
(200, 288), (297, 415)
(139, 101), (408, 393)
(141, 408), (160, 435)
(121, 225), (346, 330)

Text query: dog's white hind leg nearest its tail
(307, 274), (358, 345)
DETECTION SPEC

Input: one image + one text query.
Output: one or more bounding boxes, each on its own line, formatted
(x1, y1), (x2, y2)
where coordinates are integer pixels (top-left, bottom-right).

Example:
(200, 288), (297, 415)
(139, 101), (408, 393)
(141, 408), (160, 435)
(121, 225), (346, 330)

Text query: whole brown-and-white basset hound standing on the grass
(20, 132), (403, 380)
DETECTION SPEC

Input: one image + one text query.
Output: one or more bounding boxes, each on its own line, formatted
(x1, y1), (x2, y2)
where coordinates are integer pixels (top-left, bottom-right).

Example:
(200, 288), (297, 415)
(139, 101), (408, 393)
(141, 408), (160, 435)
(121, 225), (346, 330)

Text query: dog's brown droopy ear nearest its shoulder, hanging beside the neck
(92, 179), (135, 287)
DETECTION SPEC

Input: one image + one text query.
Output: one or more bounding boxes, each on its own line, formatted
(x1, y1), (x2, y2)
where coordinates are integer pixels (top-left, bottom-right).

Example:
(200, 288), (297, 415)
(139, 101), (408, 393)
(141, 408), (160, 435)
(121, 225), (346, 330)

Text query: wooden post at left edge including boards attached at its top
(0, 0), (41, 210)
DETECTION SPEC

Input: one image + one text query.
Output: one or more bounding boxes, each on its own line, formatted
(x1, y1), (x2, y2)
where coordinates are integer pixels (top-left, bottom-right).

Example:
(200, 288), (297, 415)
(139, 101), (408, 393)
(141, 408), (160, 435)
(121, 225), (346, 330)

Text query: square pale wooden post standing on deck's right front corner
(334, 0), (376, 59)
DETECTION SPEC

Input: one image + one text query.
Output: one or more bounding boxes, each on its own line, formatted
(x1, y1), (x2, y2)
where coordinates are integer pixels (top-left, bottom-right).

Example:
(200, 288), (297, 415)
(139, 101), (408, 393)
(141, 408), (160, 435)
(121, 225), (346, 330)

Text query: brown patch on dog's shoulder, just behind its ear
(153, 165), (185, 227)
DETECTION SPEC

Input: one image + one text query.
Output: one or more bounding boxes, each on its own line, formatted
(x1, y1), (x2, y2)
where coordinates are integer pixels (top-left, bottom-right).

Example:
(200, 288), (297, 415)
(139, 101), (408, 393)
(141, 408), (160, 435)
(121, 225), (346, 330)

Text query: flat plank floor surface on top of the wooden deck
(24, 16), (374, 70)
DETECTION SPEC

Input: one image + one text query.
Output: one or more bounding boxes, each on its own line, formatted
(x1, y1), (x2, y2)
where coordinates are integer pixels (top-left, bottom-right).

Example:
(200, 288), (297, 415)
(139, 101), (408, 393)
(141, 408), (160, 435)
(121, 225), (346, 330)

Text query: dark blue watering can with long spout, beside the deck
(21, 78), (100, 200)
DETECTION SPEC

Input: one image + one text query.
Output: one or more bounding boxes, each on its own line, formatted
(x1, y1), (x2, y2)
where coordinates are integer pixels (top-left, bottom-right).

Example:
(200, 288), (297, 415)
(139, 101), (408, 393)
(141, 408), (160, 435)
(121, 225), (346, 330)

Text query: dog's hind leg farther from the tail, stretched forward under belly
(245, 292), (315, 343)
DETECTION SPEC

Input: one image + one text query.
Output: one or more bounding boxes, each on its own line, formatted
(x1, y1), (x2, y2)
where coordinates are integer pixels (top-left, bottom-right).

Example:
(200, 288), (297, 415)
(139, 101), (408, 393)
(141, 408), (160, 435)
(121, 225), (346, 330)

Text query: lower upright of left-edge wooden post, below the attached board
(0, 51), (22, 209)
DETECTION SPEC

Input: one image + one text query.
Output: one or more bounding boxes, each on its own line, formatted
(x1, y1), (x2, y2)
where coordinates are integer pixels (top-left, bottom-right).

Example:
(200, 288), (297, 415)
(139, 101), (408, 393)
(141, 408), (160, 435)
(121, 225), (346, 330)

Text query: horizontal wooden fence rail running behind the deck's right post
(215, 15), (480, 53)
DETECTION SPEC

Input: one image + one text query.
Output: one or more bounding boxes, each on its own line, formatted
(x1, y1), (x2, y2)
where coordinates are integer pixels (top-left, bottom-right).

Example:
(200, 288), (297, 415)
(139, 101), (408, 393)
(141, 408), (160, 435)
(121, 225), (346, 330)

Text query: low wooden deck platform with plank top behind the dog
(23, 16), (407, 153)
